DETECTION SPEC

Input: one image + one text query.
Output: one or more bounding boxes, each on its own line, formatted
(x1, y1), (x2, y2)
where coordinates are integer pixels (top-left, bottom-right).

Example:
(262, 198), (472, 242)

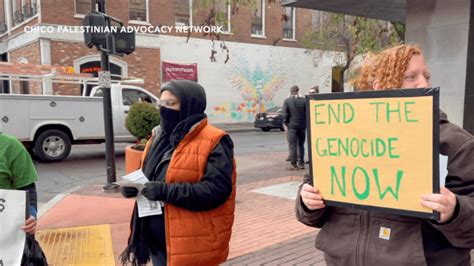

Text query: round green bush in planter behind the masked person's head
(125, 102), (160, 143)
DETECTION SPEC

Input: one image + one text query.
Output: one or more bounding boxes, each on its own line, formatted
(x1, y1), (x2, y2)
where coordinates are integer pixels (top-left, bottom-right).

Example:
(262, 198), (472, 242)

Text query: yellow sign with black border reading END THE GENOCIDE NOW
(308, 89), (439, 219)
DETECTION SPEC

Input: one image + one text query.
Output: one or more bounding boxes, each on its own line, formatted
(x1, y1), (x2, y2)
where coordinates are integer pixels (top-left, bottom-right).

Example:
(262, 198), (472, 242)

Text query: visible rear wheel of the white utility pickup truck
(34, 129), (71, 162)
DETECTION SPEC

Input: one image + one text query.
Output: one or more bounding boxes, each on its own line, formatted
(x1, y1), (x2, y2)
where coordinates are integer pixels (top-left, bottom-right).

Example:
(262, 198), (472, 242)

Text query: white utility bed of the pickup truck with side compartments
(0, 94), (104, 141)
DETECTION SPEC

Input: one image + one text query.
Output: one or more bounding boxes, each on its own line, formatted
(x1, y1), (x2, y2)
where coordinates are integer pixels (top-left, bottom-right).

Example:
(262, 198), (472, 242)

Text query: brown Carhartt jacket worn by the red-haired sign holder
(296, 112), (474, 266)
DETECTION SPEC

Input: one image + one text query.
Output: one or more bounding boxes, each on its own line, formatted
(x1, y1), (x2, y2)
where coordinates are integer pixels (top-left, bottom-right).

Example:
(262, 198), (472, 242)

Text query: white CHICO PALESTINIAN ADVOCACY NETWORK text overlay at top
(23, 25), (224, 34)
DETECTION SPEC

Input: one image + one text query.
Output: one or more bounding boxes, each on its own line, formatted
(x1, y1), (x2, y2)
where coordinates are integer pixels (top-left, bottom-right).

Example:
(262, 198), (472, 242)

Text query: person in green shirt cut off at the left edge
(0, 132), (38, 234)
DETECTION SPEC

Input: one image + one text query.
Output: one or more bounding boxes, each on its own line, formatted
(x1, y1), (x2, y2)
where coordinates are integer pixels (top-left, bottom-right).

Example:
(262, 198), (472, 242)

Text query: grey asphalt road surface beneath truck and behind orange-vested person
(35, 126), (287, 214)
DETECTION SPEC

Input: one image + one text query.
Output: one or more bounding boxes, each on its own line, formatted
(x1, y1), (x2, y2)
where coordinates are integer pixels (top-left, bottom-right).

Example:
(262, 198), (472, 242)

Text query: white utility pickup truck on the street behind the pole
(0, 84), (158, 162)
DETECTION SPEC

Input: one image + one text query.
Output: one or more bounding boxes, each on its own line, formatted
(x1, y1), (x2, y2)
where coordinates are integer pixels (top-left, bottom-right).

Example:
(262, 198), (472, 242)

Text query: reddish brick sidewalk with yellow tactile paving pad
(37, 150), (324, 265)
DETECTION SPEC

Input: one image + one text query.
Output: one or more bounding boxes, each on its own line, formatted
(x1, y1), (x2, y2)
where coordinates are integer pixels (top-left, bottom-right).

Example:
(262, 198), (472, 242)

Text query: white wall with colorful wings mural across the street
(159, 35), (333, 124)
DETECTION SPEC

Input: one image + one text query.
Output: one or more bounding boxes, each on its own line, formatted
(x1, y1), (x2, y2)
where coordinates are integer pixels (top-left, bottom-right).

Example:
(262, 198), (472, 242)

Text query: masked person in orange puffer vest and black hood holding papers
(121, 80), (236, 266)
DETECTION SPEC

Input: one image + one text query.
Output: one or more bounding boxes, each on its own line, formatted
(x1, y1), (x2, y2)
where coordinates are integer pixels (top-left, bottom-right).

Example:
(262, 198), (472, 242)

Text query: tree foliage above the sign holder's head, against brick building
(301, 11), (405, 89)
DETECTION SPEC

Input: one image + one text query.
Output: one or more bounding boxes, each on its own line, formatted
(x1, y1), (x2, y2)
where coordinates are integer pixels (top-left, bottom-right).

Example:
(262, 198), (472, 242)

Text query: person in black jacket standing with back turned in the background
(283, 85), (306, 170)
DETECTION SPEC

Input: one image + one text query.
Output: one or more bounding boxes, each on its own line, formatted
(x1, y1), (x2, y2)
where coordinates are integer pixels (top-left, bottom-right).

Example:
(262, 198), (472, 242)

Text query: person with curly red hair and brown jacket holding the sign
(296, 45), (474, 266)
